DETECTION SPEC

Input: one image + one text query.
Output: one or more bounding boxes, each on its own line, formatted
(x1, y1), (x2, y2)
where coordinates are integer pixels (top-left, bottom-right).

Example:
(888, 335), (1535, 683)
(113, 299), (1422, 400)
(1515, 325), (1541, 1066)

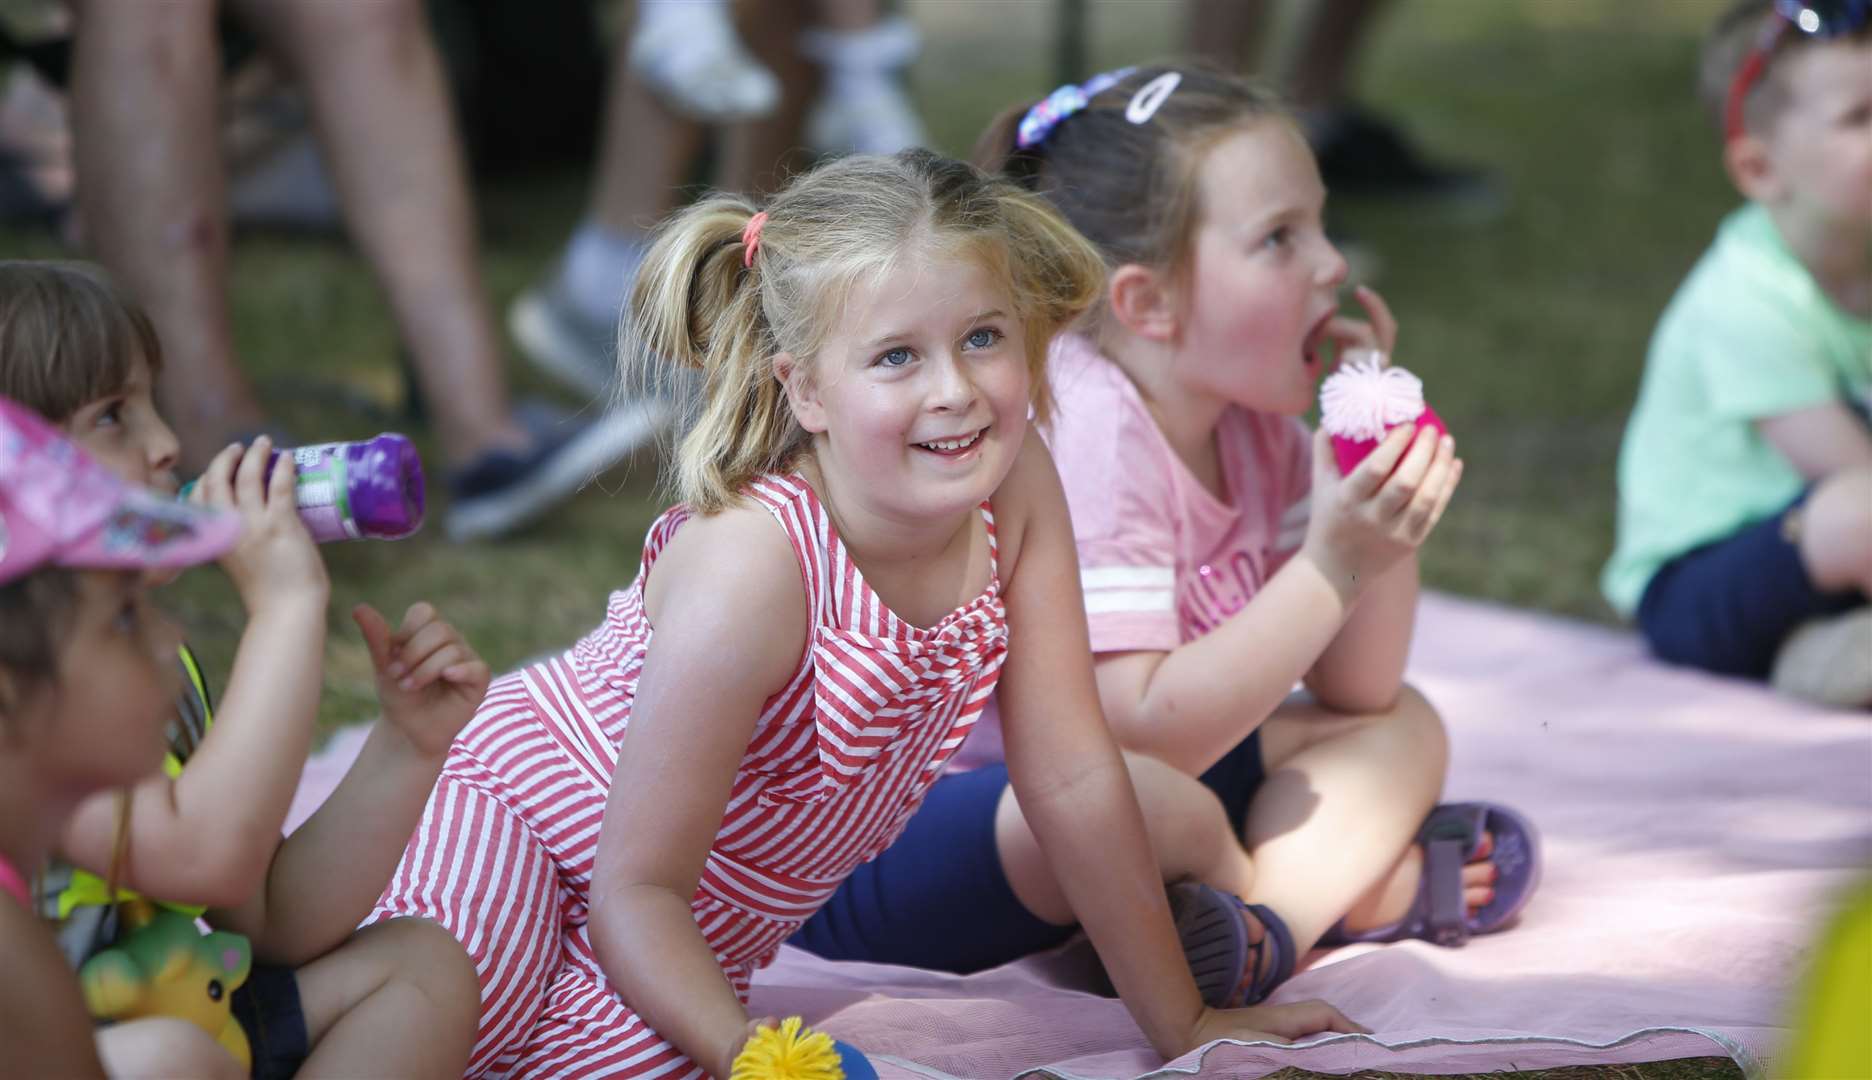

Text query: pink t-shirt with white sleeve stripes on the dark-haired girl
(951, 333), (1312, 769)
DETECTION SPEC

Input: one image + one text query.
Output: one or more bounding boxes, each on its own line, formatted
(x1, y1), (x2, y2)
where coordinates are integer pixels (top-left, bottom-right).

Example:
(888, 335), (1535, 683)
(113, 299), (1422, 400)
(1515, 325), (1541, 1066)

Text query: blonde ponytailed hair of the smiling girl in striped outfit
(618, 150), (1104, 513)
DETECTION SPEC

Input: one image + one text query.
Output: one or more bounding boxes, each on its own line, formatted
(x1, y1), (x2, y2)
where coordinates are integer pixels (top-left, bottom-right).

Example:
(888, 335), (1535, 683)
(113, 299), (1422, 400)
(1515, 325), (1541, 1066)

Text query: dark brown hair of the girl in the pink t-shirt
(975, 64), (1288, 284)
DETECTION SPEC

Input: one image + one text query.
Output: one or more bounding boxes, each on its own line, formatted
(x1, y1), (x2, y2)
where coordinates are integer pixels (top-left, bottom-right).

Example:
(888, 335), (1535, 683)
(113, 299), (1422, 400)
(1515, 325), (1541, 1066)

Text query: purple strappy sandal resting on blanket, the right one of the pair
(1320, 803), (1541, 947)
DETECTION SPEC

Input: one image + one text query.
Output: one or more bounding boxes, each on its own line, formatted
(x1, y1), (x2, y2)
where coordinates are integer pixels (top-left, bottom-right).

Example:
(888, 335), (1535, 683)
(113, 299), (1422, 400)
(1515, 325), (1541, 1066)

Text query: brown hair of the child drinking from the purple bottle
(0, 258), (163, 423)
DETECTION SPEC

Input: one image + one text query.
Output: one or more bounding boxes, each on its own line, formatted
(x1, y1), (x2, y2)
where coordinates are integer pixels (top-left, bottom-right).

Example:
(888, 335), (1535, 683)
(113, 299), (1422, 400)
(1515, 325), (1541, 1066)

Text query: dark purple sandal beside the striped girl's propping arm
(1170, 882), (1295, 1009)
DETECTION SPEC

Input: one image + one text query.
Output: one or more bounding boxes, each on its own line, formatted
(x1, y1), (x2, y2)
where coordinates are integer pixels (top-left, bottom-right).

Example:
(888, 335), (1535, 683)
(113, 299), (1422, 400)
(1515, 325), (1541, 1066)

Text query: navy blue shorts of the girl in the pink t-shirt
(788, 732), (1264, 975)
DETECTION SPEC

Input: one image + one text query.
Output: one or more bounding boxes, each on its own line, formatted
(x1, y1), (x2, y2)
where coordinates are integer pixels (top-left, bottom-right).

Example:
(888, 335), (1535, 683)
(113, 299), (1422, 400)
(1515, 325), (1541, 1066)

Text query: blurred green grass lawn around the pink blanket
(0, 0), (1737, 1080)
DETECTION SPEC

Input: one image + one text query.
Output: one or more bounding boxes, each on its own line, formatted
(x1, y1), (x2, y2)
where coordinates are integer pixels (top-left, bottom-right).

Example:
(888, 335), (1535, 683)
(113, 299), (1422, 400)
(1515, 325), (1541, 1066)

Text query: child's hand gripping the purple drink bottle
(189, 434), (331, 618)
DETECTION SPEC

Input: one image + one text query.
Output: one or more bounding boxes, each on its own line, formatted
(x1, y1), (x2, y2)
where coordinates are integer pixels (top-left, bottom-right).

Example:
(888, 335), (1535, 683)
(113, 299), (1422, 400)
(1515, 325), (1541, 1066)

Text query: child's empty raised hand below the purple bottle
(352, 603), (490, 758)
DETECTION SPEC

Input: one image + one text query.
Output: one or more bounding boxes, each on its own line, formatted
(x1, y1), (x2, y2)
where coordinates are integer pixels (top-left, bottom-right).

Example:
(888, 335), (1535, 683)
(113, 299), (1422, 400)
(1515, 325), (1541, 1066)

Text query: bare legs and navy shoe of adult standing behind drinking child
(60, 0), (651, 539)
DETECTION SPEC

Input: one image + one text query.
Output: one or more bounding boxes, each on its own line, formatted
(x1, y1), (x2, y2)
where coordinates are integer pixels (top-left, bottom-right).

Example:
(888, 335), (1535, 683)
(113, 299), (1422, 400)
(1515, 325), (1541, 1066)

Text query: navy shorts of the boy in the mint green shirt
(1638, 494), (1866, 679)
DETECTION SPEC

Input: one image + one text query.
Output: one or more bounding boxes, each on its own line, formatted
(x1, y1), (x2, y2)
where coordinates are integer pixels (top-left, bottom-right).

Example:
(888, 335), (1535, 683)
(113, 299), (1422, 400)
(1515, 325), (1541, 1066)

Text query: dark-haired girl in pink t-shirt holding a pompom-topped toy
(983, 67), (1539, 973)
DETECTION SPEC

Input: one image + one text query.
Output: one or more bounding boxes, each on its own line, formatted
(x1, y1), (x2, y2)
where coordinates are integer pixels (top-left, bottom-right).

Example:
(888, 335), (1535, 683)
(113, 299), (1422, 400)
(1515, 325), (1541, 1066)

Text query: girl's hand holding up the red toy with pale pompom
(1301, 425), (1462, 605)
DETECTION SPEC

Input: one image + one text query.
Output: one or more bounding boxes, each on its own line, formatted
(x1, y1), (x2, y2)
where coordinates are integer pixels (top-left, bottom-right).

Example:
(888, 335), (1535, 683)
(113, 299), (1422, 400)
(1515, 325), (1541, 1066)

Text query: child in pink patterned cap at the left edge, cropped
(0, 399), (241, 1078)
